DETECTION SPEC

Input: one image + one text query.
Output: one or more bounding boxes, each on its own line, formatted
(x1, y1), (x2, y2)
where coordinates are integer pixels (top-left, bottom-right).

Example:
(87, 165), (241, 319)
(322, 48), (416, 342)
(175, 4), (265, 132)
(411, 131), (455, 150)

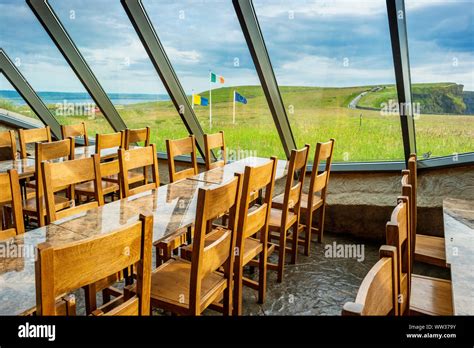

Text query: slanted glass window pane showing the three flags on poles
(144, 0), (285, 159)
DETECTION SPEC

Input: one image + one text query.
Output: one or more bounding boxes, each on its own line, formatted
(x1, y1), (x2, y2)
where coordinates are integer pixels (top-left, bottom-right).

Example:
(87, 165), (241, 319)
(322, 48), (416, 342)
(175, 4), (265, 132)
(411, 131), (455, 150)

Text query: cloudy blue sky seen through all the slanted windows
(0, 0), (474, 94)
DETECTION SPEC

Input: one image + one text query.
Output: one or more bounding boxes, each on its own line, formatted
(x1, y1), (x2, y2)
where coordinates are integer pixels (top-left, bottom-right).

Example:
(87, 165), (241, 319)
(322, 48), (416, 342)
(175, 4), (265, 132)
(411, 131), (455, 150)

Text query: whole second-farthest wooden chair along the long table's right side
(267, 145), (309, 283)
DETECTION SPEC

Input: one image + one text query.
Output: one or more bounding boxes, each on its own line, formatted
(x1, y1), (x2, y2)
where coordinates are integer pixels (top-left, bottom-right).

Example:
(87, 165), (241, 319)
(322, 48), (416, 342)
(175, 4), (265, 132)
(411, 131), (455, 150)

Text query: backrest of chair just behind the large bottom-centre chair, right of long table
(236, 157), (278, 253)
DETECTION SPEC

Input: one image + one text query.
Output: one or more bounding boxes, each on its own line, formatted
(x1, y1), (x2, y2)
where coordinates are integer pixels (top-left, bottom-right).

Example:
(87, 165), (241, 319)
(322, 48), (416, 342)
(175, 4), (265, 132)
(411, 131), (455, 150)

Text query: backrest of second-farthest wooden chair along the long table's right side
(281, 144), (309, 226)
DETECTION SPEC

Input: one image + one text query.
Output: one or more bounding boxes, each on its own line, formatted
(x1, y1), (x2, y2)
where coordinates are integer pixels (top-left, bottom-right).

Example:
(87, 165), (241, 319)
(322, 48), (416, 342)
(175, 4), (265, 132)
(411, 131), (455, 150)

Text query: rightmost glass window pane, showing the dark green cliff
(405, 0), (474, 160)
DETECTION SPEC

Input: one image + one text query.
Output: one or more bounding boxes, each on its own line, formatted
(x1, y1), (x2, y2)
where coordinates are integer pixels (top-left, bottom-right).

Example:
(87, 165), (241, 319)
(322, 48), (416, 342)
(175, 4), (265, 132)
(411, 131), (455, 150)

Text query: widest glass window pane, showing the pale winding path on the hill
(253, 0), (404, 161)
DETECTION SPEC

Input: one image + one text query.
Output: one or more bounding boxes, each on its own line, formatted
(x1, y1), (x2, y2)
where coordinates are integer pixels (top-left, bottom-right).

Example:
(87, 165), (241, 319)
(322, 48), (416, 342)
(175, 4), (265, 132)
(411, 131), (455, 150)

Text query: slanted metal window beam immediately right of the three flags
(232, 0), (297, 158)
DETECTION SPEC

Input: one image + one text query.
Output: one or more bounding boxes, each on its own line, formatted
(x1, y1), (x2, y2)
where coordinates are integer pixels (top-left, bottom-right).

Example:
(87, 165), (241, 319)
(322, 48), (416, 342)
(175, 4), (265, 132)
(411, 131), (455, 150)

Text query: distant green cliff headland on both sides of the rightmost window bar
(358, 82), (467, 115)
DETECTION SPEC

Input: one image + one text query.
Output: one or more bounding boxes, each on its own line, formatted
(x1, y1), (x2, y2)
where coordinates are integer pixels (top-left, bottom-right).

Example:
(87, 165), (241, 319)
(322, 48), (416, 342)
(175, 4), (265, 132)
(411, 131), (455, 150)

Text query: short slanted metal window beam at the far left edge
(0, 48), (61, 139)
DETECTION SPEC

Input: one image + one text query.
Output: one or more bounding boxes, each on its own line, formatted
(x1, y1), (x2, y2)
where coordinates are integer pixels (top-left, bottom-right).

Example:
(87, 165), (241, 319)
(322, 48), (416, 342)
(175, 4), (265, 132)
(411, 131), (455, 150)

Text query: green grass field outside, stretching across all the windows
(0, 86), (474, 161)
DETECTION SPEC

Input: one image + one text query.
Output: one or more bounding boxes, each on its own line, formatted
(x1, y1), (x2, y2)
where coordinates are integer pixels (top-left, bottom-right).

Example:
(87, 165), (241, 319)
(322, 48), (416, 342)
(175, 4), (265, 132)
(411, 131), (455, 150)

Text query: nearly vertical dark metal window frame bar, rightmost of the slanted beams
(386, 0), (416, 163)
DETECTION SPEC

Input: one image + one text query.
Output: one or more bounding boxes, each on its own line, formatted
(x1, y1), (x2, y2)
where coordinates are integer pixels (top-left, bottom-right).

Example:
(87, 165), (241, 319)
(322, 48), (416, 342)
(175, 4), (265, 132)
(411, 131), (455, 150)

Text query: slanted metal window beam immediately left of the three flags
(121, 0), (205, 158)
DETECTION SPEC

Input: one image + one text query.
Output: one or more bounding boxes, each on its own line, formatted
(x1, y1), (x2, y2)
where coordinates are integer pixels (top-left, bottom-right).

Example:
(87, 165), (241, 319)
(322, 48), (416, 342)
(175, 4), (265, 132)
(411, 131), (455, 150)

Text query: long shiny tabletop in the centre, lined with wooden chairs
(0, 159), (286, 315)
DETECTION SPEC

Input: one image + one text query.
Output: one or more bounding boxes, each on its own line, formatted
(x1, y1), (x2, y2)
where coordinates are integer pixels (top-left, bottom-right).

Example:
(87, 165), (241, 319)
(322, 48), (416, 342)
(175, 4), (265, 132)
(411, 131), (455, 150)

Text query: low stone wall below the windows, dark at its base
(325, 165), (474, 240)
